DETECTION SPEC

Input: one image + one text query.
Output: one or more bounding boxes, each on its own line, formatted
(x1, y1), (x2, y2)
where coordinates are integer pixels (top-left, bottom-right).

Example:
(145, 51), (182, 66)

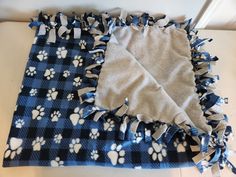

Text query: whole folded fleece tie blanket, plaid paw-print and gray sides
(3, 11), (235, 175)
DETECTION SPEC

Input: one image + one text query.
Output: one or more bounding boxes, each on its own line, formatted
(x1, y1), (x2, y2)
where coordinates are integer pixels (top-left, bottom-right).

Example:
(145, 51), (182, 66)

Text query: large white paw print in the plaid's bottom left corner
(4, 137), (23, 159)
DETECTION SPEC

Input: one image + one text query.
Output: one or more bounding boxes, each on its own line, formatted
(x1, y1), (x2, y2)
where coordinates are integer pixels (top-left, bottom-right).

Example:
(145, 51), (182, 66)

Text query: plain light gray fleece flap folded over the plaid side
(95, 25), (211, 133)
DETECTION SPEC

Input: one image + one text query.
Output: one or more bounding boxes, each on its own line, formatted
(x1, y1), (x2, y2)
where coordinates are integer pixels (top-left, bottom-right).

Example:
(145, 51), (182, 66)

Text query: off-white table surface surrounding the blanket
(0, 22), (236, 177)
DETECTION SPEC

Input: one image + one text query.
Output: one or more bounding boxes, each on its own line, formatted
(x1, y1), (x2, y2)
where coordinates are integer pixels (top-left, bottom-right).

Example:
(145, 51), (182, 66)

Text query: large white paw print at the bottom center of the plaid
(107, 143), (125, 165)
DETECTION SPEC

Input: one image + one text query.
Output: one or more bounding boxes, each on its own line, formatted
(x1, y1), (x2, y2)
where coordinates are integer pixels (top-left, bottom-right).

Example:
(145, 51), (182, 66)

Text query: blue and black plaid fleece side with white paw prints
(3, 13), (234, 174)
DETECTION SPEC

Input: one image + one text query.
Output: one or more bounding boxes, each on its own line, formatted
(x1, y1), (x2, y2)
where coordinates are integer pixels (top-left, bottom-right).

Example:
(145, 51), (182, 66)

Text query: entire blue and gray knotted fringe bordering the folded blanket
(29, 11), (236, 176)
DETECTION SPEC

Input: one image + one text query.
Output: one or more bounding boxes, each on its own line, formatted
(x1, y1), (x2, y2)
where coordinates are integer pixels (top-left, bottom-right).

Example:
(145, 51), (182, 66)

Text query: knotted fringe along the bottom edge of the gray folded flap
(78, 95), (192, 143)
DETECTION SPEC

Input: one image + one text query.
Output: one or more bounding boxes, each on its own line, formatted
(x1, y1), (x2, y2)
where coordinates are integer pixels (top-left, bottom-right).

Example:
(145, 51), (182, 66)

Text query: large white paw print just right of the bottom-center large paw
(148, 141), (167, 162)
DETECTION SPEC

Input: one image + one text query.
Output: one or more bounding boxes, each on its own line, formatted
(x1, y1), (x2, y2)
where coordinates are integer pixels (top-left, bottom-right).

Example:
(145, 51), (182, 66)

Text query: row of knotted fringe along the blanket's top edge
(29, 11), (186, 43)
